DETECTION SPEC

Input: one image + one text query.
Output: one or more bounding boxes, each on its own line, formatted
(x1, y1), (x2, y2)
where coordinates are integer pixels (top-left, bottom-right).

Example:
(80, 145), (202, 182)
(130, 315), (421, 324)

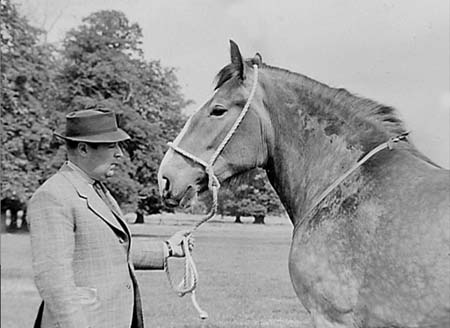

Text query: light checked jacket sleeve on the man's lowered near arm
(28, 191), (89, 328)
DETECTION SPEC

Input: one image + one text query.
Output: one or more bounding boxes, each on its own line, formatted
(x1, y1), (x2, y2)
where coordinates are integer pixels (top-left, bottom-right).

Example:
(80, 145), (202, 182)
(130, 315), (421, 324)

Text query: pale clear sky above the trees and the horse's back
(13, 0), (450, 168)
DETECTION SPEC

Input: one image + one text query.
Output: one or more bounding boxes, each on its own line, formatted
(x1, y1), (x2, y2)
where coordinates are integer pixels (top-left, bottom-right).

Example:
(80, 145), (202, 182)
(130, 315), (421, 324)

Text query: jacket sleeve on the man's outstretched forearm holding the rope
(131, 237), (165, 270)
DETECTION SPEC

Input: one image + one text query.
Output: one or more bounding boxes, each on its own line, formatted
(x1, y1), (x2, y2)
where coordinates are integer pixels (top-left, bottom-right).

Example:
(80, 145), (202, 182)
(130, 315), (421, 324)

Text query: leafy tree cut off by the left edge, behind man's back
(0, 0), (58, 202)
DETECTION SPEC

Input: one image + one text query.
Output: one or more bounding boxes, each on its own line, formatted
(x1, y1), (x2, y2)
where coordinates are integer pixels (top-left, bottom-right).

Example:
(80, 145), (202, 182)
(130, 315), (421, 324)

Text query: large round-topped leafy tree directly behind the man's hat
(59, 10), (188, 213)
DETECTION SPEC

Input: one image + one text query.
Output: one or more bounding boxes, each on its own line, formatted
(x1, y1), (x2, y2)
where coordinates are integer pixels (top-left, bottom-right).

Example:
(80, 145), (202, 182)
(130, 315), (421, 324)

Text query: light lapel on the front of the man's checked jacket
(60, 165), (129, 238)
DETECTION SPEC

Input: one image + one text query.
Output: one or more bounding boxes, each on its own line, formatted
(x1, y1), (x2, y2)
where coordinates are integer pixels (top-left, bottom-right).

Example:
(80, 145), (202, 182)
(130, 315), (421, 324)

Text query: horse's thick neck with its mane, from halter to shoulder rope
(260, 68), (436, 224)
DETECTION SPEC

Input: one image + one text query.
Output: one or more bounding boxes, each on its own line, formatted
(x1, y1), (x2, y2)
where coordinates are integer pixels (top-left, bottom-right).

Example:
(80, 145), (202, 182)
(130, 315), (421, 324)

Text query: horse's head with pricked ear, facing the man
(158, 41), (273, 206)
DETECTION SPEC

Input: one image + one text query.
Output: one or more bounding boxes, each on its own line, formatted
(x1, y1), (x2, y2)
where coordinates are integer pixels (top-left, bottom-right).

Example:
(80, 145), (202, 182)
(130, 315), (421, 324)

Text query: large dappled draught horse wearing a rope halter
(158, 41), (450, 328)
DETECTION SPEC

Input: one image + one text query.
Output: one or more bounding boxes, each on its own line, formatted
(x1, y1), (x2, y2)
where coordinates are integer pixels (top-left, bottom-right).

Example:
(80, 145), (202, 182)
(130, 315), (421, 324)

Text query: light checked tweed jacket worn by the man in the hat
(28, 163), (164, 328)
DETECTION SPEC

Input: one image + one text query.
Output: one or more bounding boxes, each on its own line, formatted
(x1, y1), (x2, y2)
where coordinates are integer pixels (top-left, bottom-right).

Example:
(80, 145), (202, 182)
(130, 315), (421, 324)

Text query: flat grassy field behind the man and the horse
(1, 215), (311, 328)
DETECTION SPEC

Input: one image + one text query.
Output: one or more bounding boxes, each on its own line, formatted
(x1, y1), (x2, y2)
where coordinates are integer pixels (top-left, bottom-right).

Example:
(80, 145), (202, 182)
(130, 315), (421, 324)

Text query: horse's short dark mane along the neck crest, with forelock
(214, 59), (440, 167)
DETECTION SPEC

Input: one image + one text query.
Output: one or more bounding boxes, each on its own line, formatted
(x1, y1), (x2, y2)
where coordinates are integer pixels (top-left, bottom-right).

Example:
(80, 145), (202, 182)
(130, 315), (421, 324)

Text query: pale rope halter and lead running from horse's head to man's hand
(164, 64), (258, 319)
